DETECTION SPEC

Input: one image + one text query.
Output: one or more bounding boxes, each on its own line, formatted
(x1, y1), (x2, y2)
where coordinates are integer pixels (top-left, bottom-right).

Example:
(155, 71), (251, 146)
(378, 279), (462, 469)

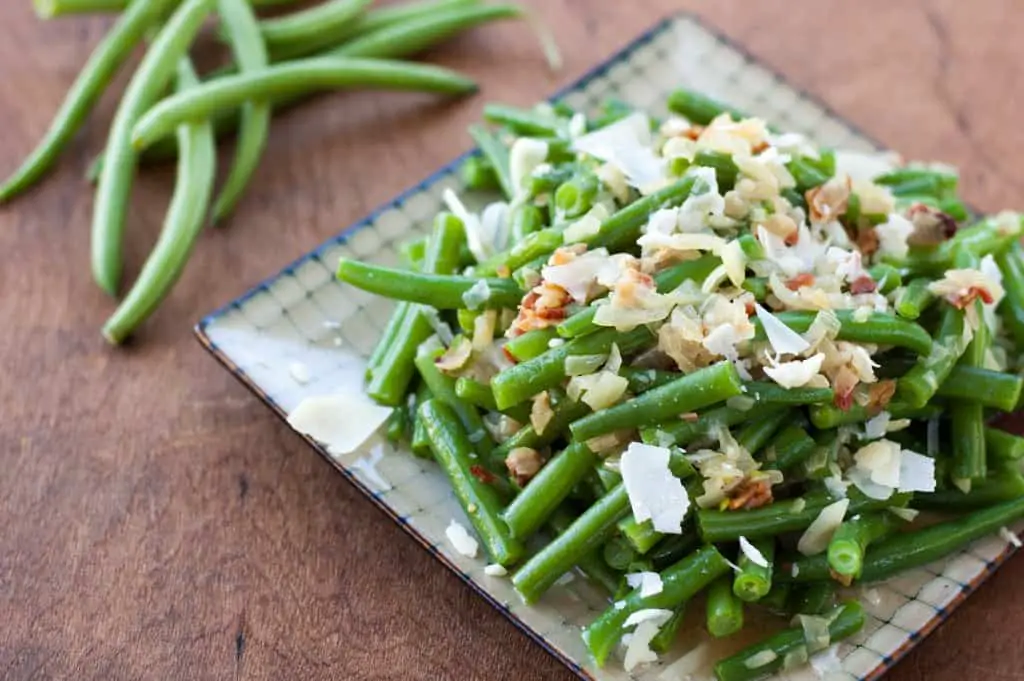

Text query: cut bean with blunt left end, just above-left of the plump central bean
(490, 327), (652, 414)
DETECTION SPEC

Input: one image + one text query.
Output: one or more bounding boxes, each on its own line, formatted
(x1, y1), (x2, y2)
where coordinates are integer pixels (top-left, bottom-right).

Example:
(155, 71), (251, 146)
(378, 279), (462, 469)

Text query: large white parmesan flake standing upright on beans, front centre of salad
(620, 442), (690, 535)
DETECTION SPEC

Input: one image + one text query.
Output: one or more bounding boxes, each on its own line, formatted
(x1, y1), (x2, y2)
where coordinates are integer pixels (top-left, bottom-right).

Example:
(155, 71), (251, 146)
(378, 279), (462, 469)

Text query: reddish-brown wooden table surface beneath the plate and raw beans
(0, 0), (1024, 681)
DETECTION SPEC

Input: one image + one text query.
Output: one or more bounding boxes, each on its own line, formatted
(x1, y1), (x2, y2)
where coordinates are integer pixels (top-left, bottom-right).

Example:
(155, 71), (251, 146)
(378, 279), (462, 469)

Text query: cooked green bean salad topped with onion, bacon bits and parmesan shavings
(319, 90), (1024, 681)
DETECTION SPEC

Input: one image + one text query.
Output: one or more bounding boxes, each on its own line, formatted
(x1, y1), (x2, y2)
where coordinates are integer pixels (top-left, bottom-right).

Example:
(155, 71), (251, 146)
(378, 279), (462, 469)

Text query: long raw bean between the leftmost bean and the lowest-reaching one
(92, 0), (213, 294)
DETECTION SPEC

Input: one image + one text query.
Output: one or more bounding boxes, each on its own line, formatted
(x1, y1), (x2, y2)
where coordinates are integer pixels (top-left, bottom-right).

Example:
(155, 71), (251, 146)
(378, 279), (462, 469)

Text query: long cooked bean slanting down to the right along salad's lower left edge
(419, 399), (523, 567)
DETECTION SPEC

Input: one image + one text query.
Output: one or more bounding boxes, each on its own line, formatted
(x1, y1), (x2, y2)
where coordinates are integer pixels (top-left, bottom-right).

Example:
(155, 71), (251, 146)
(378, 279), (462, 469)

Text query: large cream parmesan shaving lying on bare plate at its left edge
(288, 394), (391, 456)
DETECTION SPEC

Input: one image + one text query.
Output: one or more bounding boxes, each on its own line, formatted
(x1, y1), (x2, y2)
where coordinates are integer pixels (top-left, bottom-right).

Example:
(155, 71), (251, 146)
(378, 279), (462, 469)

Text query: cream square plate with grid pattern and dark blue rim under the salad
(197, 14), (1013, 681)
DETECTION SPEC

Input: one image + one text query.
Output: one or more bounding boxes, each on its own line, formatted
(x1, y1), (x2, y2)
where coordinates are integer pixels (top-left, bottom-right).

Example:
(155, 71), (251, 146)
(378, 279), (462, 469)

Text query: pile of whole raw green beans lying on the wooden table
(0, 0), (548, 344)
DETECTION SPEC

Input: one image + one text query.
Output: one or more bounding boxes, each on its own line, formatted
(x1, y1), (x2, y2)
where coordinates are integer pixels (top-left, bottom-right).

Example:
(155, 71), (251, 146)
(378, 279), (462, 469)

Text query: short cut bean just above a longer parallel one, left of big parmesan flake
(502, 442), (598, 539)
